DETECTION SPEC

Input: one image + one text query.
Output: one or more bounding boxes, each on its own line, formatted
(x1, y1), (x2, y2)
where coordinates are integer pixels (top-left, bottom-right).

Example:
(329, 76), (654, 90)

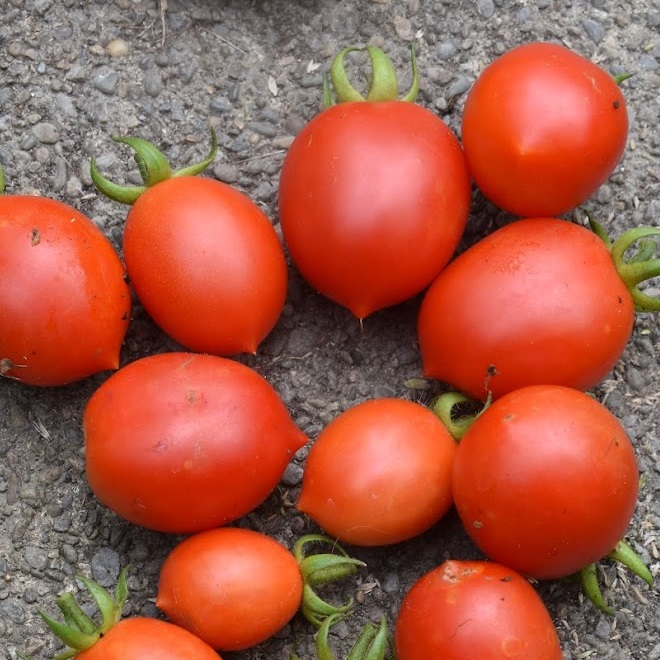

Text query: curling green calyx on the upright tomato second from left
(89, 127), (218, 205)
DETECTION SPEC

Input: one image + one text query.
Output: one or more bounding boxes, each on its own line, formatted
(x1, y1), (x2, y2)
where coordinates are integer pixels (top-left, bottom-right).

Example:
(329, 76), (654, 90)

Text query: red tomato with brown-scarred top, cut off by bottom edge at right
(394, 560), (562, 660)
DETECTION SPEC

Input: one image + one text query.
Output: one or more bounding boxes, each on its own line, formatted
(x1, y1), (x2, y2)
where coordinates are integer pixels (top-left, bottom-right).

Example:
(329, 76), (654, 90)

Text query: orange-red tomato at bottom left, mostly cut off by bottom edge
(75, 617), (222, 660)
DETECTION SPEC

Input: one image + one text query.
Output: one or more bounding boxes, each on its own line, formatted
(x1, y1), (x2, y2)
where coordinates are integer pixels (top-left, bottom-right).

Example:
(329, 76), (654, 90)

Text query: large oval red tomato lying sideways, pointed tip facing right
(83, 353), (307, 533)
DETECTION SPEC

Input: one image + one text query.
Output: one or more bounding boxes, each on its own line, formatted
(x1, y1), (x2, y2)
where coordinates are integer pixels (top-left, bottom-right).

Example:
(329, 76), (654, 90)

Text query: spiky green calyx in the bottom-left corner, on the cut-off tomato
(39, 567), (128, 660)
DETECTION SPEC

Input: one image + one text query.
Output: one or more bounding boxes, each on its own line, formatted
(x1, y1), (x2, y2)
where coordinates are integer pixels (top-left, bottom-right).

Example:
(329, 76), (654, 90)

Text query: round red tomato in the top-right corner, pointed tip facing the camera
(461, 43), (628, 217)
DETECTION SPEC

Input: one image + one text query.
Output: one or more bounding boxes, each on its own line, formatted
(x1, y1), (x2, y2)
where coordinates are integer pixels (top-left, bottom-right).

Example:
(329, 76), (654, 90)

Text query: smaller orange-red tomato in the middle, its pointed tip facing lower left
(297, 398), (456, 545)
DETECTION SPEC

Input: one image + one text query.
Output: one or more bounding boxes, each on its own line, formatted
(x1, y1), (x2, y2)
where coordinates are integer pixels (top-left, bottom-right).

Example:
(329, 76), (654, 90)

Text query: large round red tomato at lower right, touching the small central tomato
(452, 385), (639, 579)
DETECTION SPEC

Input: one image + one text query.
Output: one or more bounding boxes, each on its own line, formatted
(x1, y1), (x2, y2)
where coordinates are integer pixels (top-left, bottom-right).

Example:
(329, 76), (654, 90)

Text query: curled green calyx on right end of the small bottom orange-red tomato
(293, 534), (366, 628)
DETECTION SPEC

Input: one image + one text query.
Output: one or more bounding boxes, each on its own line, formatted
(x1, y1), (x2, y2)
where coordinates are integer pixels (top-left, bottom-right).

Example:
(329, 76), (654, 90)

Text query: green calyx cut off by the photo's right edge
(586, 212), (660, 312)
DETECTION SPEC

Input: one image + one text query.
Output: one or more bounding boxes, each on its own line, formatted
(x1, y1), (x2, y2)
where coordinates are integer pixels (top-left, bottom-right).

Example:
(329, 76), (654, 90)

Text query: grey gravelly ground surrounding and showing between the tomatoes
(0, 0), (660, 660)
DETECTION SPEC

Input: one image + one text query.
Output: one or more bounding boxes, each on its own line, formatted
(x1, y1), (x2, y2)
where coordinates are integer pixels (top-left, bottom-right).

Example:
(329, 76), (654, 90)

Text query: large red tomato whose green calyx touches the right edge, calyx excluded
(418, 218), (635, 400)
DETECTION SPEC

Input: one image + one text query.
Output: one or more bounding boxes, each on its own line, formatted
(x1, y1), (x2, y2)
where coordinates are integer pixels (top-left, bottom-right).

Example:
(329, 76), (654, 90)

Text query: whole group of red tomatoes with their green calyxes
(0, 43), (660, 660)
